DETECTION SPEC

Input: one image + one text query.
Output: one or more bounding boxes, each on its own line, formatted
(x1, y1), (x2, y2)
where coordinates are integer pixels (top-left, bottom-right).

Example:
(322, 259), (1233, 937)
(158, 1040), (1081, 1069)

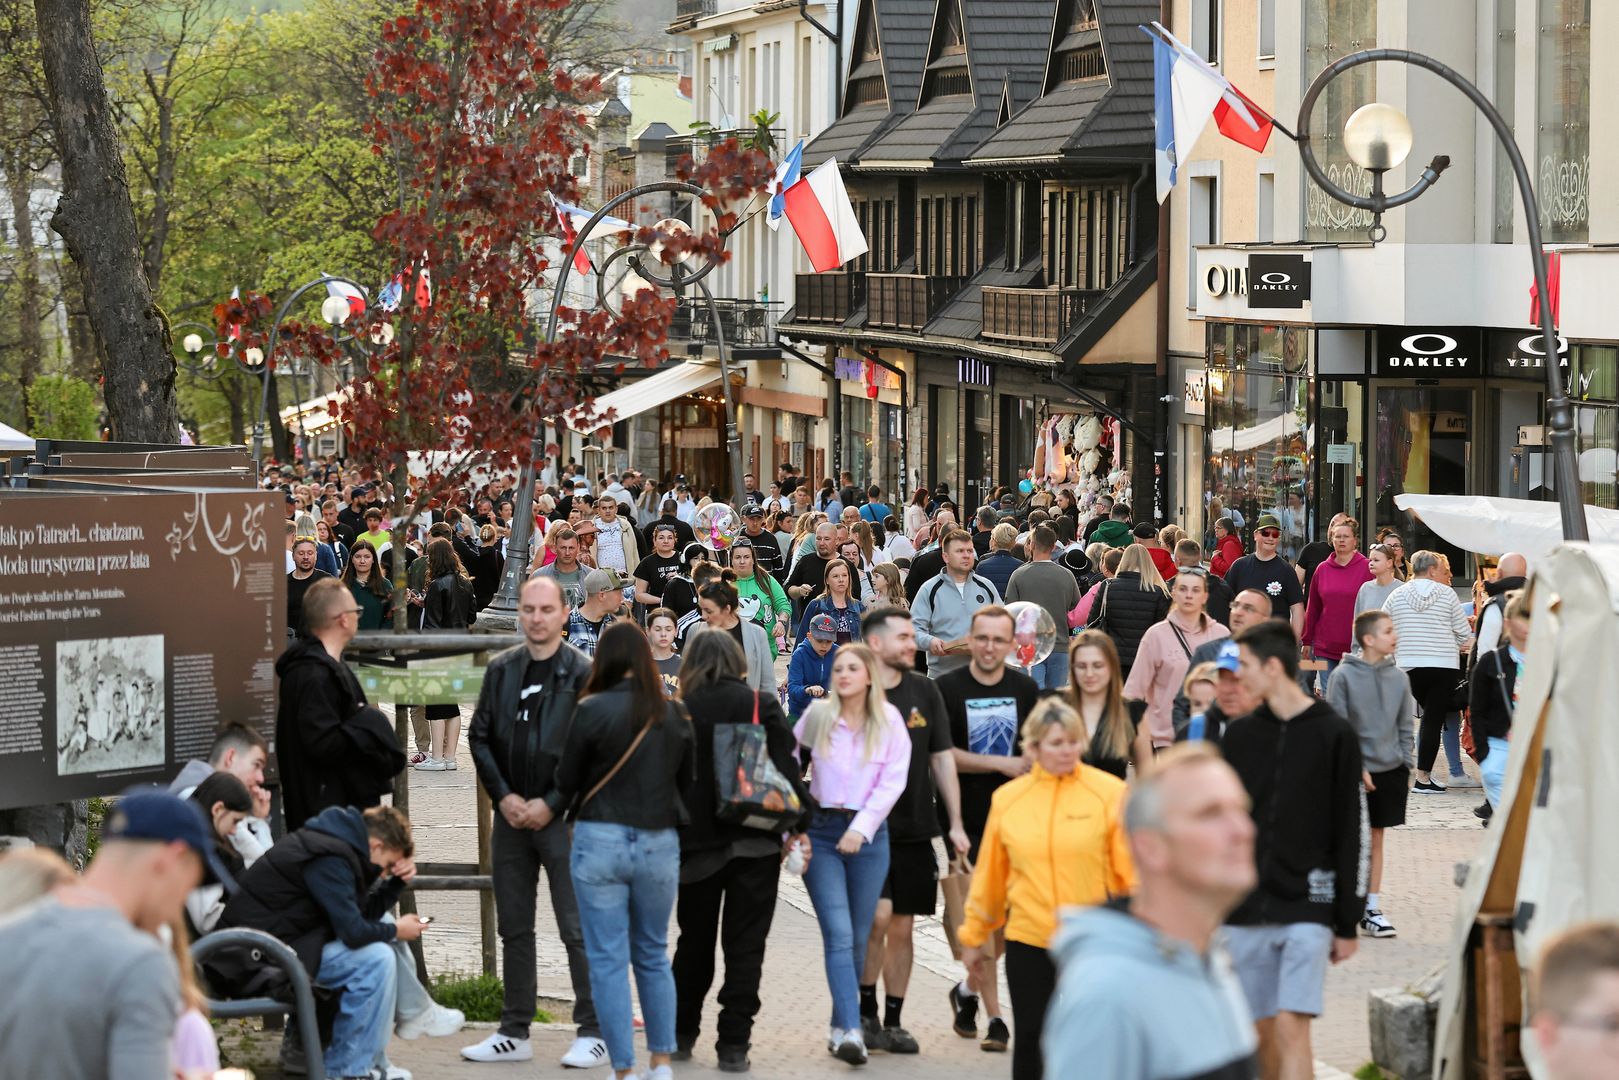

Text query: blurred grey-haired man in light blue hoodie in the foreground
(1043, 742), (1260, 1080)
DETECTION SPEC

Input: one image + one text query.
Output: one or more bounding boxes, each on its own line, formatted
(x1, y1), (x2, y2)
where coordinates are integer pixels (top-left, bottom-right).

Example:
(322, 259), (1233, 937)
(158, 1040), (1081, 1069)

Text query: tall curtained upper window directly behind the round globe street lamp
(1303, 0), (1378, 243)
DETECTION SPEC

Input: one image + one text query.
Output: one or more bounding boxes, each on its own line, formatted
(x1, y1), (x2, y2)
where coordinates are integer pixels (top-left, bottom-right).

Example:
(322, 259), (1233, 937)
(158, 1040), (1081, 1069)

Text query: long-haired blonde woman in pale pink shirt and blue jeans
(793, 644), (910, 1065)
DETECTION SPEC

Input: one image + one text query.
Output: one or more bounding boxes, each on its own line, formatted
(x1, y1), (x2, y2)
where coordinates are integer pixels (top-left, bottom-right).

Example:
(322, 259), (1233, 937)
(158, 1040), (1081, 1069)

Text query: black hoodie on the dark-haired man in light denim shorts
(1221, 701), (1370, 938)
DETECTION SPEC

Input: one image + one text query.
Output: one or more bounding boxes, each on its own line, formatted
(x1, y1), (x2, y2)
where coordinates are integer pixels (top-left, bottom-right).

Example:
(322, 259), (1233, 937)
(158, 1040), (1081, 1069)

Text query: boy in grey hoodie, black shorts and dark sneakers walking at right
(1326, 607), (1417, 938)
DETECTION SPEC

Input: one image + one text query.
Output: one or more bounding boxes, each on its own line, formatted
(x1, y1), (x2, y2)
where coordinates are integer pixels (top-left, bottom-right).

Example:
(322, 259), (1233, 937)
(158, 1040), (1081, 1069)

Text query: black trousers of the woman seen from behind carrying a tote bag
(674, 855), (782, 1048)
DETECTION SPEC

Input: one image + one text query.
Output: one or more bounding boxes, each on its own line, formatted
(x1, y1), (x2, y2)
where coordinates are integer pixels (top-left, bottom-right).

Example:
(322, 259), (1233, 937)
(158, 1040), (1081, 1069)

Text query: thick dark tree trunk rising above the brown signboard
(34, 0), (180, 442)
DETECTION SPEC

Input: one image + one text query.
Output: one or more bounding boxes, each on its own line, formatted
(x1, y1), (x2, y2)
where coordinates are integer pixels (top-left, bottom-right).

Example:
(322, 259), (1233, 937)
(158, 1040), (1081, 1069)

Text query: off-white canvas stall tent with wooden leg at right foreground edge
(1433, 540), (1619, 1080)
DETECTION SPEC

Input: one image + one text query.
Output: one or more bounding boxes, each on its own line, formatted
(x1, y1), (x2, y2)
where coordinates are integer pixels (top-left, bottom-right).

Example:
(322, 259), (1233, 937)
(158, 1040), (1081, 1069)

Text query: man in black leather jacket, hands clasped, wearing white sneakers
(461, 576), (607, 1069)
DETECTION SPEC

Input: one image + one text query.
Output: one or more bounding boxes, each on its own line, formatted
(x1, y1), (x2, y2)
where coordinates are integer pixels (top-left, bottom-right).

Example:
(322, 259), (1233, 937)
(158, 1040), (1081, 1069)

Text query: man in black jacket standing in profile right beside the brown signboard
(275, 578), (405, 831)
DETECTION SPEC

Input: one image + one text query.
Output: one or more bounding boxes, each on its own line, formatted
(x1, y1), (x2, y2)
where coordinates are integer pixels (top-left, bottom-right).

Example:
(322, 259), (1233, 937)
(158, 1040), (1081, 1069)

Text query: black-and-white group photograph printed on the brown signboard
(57, 633), (167, 776)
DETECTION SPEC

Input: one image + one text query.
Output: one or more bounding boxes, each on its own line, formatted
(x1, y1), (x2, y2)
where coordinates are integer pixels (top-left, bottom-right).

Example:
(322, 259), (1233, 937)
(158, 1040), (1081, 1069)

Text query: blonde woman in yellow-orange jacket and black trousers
(957, 696), (1135, 1080)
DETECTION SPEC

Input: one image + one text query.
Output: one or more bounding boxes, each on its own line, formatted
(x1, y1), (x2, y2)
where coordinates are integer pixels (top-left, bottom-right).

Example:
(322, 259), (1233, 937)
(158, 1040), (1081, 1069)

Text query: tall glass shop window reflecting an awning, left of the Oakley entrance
(1205, 322), (1315, 559)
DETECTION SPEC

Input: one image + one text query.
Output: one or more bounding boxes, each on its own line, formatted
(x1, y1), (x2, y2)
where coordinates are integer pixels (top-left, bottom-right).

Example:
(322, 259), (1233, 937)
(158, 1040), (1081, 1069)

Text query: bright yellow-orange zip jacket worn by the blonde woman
(960, 764), (1135, 949)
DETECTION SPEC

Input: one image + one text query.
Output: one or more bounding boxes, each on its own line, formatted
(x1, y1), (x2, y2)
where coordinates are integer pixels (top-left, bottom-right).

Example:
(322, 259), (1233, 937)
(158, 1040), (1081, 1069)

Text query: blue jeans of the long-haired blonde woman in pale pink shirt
(805, 810), (889, 1031)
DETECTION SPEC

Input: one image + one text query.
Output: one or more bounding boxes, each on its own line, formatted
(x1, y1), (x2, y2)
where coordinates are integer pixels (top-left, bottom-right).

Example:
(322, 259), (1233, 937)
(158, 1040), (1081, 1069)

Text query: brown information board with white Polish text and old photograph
(0, 491), (287, 808)
